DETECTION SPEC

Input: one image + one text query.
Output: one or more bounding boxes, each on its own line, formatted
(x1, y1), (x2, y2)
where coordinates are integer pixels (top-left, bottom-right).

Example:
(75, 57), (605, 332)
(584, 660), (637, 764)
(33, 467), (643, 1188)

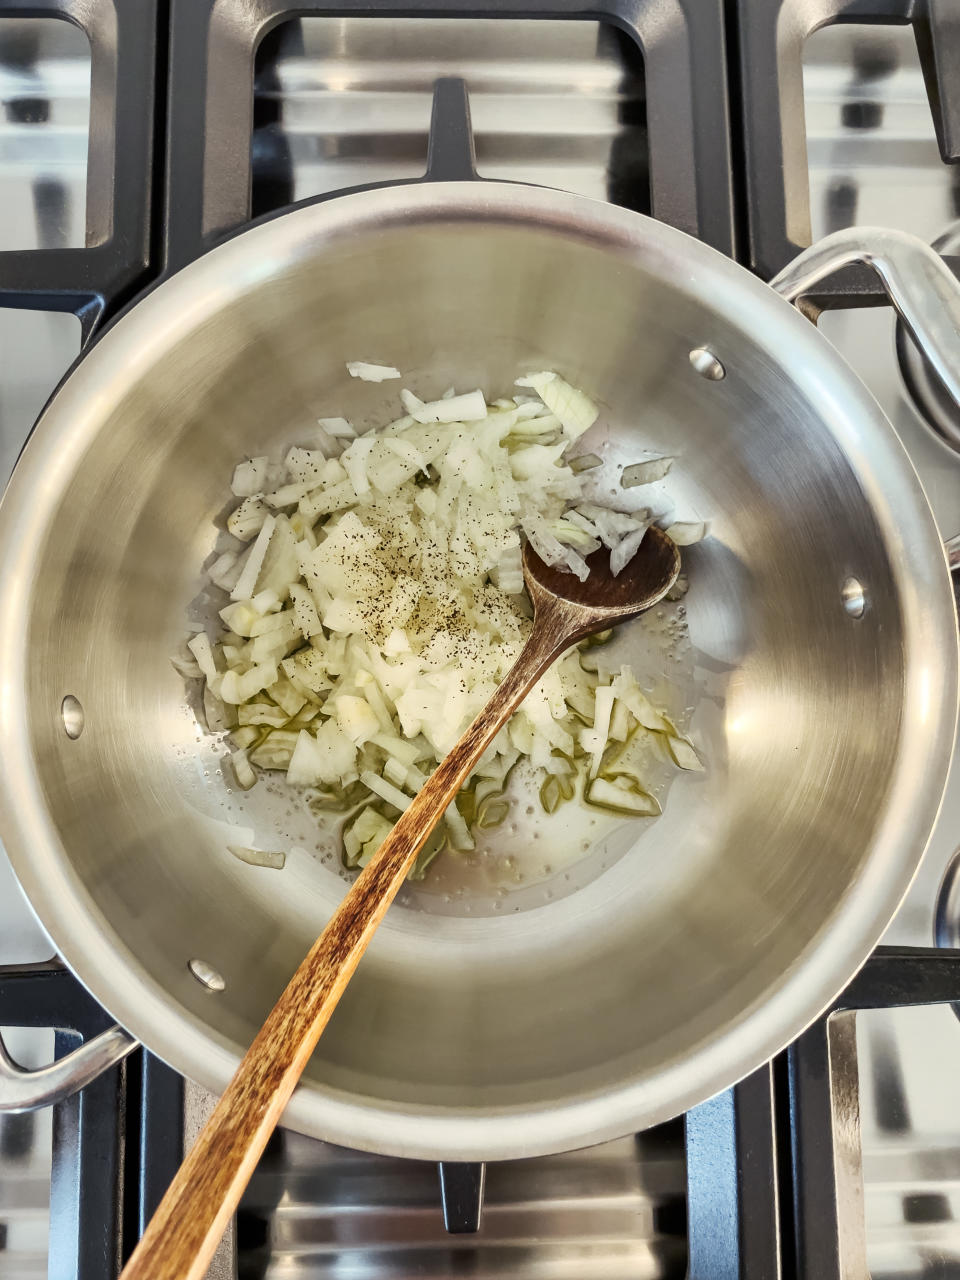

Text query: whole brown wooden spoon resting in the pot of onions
(122, 526), (680, 1280)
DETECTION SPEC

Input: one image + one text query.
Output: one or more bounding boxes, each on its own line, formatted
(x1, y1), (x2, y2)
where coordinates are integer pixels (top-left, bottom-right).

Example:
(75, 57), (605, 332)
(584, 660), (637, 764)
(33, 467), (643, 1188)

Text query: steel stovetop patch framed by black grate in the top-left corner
(0, 17), (90, 250)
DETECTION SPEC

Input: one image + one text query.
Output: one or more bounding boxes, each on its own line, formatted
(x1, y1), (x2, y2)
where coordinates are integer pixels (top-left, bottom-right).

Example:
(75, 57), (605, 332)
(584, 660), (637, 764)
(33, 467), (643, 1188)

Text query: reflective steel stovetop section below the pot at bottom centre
(239, 1126), (686, 1280)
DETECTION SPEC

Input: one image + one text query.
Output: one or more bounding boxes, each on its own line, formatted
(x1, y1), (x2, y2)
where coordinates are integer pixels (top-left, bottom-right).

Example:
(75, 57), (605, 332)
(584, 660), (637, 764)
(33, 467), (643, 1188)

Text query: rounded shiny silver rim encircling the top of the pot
(0, 182), (957, 1160)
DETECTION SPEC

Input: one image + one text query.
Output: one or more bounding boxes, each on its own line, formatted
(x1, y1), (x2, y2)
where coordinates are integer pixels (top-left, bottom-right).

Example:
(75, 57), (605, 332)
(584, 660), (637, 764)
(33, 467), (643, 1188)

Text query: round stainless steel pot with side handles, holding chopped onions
(0, 183), (960, 1160)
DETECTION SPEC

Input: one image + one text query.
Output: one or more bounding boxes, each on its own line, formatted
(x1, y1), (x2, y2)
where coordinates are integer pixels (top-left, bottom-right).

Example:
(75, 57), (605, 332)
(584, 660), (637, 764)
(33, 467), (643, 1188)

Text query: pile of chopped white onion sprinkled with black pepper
(184, 364), (703, 877)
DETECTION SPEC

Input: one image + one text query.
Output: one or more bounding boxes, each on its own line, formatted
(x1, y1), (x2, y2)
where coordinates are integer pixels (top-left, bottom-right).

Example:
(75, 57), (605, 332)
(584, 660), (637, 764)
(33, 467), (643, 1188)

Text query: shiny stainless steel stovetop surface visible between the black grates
(0, 6), (960, 1280)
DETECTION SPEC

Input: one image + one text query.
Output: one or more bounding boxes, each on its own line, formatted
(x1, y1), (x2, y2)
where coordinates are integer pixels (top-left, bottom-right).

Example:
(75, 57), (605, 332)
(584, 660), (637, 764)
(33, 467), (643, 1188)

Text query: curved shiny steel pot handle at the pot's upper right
(771, 227), (960, 404)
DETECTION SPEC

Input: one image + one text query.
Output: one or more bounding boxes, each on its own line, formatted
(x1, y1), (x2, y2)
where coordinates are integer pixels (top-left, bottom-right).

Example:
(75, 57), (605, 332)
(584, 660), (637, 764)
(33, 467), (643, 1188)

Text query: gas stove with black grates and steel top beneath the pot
(0, 0), (960, 1280)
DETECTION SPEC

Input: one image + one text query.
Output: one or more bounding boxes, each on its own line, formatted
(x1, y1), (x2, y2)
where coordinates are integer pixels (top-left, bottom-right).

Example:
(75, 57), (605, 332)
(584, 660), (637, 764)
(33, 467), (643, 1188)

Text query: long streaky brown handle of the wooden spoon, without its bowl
(122, 609), (567, 1280)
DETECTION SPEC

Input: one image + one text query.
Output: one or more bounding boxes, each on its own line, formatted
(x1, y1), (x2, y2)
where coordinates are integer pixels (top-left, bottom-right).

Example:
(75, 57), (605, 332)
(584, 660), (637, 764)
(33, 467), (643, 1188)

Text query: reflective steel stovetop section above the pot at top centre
(251, 17), (649, 212)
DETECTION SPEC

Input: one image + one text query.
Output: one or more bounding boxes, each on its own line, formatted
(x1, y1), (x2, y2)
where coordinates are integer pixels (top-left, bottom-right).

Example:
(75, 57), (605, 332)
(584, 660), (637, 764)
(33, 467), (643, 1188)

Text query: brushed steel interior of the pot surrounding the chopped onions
(3, 192), (948, 1155)
